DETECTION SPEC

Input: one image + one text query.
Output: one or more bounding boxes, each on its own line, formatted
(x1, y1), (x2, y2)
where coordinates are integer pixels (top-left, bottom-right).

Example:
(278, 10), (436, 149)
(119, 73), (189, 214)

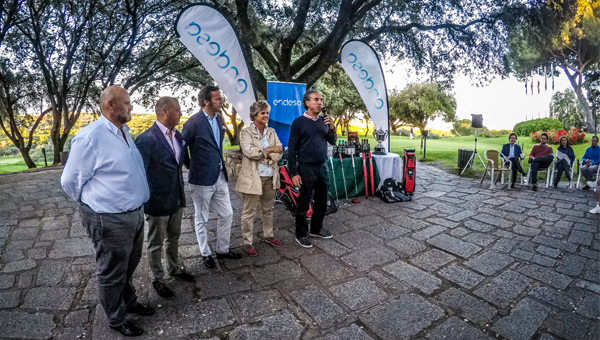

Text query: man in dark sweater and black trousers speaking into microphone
(288, 91), (337, 248)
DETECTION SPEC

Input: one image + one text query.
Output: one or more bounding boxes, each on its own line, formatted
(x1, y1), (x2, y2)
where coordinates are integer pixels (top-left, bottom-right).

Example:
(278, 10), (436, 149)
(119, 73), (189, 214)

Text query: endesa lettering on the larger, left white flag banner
(185, 21), (248, 93)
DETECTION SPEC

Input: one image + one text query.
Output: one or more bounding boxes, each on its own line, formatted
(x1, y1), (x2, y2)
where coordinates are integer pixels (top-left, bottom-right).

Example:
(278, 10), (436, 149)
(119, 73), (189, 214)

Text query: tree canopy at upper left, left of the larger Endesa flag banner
(0, 0), (206, 166)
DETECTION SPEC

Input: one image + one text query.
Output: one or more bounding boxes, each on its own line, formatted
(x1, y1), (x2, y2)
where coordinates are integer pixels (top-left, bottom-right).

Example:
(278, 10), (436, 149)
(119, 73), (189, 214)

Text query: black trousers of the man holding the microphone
(296, 165), (327, 237)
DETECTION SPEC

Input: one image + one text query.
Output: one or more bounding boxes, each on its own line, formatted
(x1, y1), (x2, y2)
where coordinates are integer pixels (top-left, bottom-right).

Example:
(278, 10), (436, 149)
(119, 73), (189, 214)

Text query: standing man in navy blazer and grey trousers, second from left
(135, 97), (194, 299)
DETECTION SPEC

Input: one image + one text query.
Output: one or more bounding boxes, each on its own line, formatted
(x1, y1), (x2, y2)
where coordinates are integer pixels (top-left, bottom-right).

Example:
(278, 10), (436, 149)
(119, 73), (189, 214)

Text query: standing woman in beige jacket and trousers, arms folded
(235, 100), (283, 256)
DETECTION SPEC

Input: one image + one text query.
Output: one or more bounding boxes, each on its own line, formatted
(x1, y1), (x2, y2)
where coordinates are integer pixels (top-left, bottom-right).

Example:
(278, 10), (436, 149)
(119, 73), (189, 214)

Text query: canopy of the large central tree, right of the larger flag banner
(209, 0), (520, 95)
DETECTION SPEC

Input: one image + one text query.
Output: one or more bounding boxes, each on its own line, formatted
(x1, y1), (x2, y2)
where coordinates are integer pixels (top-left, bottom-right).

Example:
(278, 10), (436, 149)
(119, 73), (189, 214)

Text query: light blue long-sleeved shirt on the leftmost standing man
(60, 116), (150, 213)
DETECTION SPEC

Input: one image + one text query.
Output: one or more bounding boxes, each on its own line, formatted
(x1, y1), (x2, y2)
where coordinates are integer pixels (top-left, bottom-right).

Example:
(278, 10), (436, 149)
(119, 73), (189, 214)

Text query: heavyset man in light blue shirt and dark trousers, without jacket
(61, 86), (154, 336)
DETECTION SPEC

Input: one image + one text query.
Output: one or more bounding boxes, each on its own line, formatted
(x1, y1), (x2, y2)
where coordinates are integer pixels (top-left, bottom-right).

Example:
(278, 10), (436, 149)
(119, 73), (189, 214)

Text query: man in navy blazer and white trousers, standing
(182, 85), (242, 269)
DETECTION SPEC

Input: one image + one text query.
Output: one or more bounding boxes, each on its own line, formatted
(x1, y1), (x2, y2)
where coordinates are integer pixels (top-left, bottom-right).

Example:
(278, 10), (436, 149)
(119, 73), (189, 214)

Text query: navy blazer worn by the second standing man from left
(135, 123), (188, 216)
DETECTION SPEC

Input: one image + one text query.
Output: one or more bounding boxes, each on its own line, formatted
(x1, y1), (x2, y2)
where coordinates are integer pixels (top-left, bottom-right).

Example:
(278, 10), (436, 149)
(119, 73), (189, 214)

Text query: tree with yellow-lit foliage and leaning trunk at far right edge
(508, 0), (600, 131)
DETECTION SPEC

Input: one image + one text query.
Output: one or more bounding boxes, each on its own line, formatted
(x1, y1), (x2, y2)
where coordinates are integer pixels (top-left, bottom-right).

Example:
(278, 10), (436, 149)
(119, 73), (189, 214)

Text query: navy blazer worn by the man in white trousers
(181, 111), (227, 186)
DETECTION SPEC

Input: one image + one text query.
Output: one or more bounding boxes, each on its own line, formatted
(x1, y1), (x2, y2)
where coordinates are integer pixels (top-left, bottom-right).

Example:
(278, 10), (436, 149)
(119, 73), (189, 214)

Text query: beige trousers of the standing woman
(242, 177), (275, 246)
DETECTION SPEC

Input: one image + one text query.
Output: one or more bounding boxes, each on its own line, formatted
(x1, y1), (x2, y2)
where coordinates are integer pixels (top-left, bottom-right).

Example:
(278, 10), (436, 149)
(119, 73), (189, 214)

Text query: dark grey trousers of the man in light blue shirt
(79, 204), (144, 327)
